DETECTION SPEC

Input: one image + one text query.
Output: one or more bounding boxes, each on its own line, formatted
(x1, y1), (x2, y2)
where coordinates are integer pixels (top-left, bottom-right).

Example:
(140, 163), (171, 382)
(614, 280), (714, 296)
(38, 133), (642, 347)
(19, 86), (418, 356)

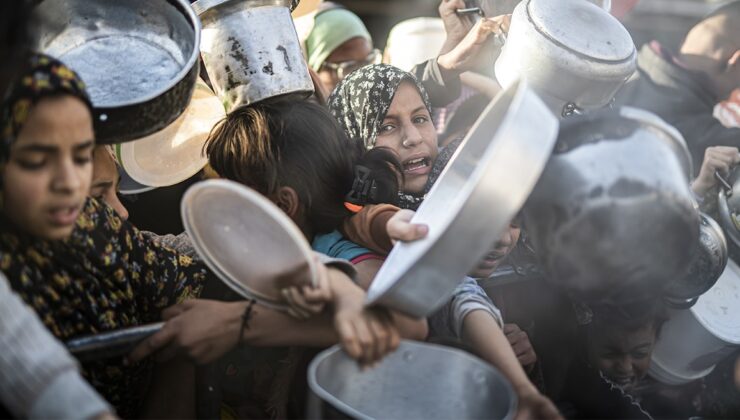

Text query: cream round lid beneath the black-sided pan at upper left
(116, 80), (226, 187)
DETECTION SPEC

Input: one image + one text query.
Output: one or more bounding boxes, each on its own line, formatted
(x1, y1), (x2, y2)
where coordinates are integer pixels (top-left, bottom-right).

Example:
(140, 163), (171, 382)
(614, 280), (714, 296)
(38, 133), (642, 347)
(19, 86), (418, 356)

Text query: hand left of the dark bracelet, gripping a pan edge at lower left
(127, 299), (243, 364)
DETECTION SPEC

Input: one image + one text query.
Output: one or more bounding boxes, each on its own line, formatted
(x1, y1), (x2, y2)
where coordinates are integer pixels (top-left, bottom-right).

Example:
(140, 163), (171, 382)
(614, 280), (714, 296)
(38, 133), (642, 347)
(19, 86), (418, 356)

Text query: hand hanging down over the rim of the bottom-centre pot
(331, 276), (401, 365)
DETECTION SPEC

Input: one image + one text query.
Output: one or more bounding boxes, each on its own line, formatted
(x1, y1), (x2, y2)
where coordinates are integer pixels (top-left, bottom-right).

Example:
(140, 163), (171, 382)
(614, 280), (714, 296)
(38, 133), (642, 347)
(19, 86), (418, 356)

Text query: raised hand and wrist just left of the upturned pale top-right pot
(437, 15), (511, 73)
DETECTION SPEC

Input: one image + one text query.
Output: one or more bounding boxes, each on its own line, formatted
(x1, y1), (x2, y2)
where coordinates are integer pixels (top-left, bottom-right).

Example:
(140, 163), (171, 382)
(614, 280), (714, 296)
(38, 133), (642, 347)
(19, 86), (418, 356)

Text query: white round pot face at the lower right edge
(691, 260), (740, 344)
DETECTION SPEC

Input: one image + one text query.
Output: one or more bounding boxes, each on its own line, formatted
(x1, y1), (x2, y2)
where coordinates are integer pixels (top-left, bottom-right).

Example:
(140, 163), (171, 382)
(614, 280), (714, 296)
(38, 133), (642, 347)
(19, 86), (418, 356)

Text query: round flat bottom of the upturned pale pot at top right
(527, 0), (635, 62)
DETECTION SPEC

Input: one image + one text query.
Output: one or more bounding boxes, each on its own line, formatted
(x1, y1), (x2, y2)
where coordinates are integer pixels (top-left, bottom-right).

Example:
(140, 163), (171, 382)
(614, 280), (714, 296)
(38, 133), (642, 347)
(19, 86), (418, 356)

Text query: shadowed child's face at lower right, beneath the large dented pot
(588, 324), (656, 389)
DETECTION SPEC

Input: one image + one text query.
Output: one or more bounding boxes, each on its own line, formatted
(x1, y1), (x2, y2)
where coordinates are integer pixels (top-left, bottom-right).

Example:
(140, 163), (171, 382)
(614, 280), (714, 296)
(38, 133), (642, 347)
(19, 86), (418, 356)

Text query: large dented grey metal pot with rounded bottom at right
(524, 107), (699, 304)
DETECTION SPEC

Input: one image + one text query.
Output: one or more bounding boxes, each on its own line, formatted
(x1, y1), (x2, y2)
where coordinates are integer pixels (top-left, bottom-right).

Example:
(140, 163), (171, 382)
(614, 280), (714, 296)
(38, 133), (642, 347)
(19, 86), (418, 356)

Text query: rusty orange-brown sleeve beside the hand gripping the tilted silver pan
(342, 204), (399, 255)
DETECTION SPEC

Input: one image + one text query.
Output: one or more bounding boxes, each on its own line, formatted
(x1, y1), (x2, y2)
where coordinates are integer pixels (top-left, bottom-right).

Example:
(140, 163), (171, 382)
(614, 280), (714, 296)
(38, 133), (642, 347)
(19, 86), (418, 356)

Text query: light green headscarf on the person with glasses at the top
(306, 8), (372, 71)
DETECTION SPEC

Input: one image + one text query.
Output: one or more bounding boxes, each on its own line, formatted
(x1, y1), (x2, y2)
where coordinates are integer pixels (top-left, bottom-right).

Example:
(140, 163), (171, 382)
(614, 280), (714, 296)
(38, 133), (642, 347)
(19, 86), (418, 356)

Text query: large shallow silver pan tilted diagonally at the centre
(367, 81), (558, 317)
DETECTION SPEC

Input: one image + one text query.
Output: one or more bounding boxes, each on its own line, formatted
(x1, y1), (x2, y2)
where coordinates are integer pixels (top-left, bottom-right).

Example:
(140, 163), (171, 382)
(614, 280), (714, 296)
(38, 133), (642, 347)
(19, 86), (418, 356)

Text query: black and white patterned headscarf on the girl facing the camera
(328, 64), (432, 150)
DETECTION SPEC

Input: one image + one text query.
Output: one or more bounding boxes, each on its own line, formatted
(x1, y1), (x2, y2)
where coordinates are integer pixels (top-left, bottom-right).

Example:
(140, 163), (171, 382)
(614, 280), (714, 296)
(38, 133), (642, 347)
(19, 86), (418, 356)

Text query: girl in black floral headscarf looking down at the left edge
(0, 55), (207, 417)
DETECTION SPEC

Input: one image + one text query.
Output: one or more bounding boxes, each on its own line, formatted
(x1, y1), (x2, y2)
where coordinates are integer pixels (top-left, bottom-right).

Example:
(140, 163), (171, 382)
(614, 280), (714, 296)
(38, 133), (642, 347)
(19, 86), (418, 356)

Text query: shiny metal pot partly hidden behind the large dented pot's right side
(665, 213), (728, 307)
